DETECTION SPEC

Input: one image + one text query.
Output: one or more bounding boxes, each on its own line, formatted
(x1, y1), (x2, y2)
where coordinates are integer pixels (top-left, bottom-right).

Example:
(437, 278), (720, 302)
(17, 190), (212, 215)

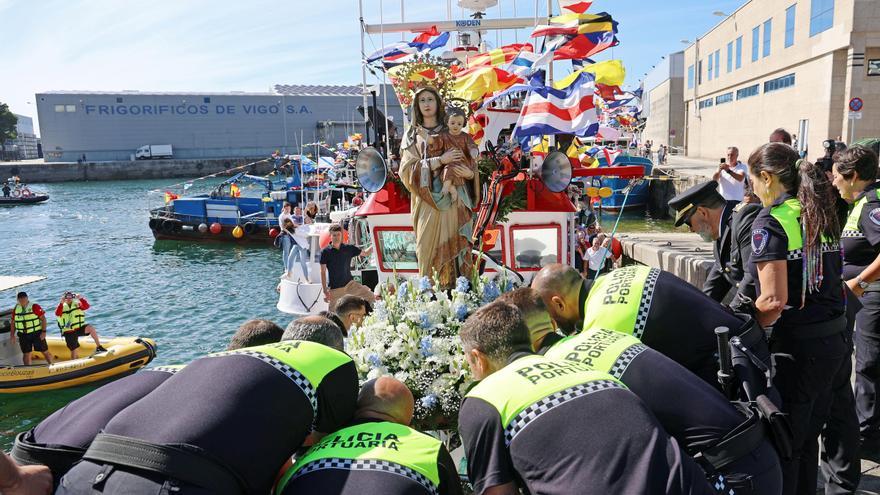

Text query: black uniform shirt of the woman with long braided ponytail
(749, 194), (844, 328)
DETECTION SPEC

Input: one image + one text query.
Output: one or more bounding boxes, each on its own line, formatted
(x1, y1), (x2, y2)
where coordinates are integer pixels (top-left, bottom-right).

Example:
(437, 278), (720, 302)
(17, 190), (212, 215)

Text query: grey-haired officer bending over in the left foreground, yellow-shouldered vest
(56, 316), (358, 495)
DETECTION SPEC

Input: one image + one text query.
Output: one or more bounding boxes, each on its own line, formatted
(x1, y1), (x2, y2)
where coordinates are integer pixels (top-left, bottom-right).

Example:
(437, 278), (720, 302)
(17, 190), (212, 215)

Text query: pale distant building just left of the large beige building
(642, 52), (684, 151)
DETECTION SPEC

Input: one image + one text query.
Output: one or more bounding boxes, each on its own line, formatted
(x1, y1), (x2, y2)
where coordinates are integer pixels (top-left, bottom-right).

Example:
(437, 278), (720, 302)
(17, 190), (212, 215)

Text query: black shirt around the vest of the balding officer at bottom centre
(281, 420), (462, 495)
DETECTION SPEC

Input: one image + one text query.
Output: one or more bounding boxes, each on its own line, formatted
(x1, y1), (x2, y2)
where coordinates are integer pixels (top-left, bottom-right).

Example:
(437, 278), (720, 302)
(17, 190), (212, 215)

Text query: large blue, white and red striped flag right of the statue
(514, 72), (599, 140)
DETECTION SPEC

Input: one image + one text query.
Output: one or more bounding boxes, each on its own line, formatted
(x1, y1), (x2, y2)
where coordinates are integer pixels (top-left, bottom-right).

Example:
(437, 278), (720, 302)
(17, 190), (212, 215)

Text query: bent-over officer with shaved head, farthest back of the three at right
(532, 264), (770, 398)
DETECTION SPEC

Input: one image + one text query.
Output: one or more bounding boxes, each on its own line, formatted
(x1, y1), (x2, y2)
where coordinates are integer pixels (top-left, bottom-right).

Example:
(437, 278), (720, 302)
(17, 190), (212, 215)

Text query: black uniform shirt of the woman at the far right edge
(840, 183), (880, 280)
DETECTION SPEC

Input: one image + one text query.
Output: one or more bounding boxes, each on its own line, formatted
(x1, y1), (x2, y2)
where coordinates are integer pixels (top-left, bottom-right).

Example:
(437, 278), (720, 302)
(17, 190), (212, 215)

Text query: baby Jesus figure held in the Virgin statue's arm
(422, 108), (479, 202)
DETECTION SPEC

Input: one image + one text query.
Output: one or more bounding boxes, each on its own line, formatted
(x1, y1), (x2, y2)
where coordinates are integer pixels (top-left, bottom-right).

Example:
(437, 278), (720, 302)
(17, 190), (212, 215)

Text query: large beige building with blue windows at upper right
(680, 0), (880, 158)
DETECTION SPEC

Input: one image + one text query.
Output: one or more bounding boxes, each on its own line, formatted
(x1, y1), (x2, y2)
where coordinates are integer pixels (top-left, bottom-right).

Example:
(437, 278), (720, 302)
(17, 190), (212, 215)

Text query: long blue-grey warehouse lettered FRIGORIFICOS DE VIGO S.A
(36, 85), (403, 161)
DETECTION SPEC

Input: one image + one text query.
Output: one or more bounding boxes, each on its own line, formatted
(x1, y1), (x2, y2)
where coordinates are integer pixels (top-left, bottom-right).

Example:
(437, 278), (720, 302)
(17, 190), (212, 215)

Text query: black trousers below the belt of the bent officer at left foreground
(55, 461), (211, 495)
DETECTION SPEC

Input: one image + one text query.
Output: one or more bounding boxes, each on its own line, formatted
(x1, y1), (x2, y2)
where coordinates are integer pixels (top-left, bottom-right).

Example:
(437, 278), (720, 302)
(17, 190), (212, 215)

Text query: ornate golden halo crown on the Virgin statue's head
(388, 55), (455, 107)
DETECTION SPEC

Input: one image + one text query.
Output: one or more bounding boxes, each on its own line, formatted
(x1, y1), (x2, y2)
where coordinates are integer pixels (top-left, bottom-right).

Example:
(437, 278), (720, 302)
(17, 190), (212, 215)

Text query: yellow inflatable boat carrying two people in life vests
(0, 276), (156, 394)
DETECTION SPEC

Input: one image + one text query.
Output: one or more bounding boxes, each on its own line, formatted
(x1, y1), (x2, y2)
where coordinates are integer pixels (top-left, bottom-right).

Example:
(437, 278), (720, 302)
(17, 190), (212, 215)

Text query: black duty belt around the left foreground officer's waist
(83, 433), (251, 495)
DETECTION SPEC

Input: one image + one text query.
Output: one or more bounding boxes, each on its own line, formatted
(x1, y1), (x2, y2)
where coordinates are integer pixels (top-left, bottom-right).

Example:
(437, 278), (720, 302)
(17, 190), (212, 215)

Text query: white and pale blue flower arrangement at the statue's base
(346, 277), (513, 430)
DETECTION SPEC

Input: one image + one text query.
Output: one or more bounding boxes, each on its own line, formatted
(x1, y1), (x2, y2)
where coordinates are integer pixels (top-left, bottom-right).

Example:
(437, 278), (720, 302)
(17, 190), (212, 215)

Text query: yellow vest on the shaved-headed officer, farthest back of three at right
(583, 266), (660, 339)
